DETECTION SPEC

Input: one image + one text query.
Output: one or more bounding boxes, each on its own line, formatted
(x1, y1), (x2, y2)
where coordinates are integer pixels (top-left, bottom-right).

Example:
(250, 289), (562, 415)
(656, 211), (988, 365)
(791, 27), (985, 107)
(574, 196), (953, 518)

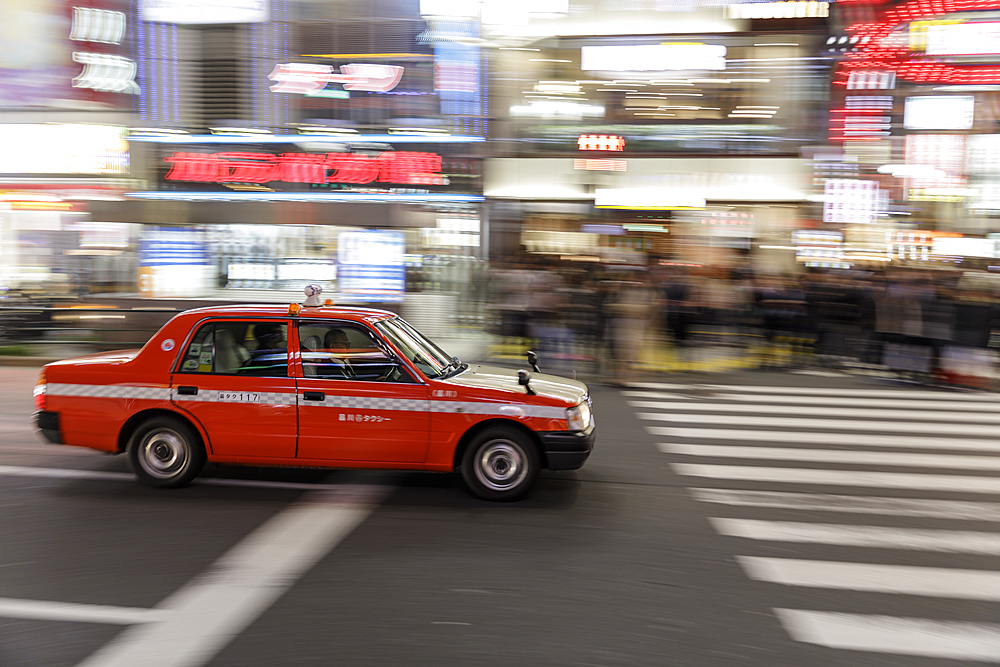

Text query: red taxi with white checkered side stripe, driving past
(35, 301), (595, 500)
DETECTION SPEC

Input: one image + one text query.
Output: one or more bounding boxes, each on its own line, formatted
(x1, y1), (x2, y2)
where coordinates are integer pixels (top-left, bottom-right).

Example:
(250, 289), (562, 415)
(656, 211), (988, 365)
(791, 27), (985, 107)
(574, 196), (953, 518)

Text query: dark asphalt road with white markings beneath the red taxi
(0, 368), (1000, 667)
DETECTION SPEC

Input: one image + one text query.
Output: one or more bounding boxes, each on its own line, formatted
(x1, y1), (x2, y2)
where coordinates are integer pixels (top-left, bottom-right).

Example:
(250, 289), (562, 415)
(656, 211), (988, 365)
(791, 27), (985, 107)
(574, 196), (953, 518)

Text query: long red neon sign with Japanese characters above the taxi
(164, 151), (443, 185)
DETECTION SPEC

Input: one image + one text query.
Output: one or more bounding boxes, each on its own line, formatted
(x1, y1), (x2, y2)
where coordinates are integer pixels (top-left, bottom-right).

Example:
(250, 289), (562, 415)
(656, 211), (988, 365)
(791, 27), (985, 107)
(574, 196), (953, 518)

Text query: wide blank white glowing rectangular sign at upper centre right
(580, 44), (726, 72)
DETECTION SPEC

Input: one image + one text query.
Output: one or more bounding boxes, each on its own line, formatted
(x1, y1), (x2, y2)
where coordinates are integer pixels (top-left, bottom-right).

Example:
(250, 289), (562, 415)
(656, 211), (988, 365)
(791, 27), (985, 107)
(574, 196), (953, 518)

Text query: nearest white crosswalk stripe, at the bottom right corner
(774, 609), (1000, 662)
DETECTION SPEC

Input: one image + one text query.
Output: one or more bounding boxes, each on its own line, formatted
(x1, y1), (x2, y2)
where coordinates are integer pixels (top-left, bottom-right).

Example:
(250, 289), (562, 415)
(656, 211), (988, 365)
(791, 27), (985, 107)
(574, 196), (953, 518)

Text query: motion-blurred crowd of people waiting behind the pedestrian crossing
(489, 259), (1000, 382)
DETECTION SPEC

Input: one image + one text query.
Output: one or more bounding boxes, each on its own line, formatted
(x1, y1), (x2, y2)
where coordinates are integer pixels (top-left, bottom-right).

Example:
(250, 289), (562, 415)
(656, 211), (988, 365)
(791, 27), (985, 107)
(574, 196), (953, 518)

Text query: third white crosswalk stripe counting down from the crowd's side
(627, 401), (1000, 422)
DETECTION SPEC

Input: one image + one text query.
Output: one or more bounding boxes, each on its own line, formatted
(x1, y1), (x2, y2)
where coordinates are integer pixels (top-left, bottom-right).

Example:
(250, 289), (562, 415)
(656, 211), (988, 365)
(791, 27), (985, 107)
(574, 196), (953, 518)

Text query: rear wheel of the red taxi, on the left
(128, 417), (205, 488)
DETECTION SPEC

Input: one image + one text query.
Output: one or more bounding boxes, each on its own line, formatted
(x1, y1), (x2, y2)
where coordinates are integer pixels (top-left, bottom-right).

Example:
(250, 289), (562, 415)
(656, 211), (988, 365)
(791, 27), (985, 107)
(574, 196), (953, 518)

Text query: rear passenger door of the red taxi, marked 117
(171, 319), (298, 462)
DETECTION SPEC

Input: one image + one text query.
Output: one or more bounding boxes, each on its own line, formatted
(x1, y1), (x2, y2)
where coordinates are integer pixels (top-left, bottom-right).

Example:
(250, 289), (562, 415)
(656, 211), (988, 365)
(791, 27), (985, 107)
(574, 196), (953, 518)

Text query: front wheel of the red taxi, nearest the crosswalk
(462, 426), (540, 502)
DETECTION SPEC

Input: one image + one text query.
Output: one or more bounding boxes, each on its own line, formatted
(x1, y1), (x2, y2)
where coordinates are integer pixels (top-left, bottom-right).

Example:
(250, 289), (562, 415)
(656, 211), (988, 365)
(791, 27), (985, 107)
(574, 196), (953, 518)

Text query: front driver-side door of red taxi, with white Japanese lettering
(297, 320), (430, 466)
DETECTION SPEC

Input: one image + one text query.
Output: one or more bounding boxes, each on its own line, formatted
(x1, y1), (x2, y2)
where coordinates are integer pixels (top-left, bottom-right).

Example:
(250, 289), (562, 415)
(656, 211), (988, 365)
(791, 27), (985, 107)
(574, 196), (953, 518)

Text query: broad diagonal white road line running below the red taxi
(79, 485), (390, 667)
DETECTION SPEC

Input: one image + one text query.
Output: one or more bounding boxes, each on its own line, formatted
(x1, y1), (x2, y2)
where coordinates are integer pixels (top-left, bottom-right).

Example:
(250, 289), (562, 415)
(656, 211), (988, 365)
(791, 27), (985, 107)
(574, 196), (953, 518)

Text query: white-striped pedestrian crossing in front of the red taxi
(622, 383), (1000, 662)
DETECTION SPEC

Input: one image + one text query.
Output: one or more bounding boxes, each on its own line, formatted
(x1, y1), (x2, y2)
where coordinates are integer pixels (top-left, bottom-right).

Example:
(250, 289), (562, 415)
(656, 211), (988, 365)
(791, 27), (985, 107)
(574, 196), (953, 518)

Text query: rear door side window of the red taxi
(180, 321), (288, 377)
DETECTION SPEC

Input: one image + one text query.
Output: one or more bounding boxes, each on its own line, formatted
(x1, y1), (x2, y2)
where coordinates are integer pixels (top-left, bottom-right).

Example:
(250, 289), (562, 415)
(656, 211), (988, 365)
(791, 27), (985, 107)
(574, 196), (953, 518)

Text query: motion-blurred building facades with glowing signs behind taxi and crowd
(0, 0), (1000, 302)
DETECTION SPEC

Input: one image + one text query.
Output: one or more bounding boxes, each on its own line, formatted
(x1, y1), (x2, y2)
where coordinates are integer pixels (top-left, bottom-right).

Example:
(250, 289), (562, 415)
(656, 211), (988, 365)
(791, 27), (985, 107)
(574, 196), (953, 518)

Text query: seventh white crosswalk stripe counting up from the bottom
(646, 426), (1000, 452)
